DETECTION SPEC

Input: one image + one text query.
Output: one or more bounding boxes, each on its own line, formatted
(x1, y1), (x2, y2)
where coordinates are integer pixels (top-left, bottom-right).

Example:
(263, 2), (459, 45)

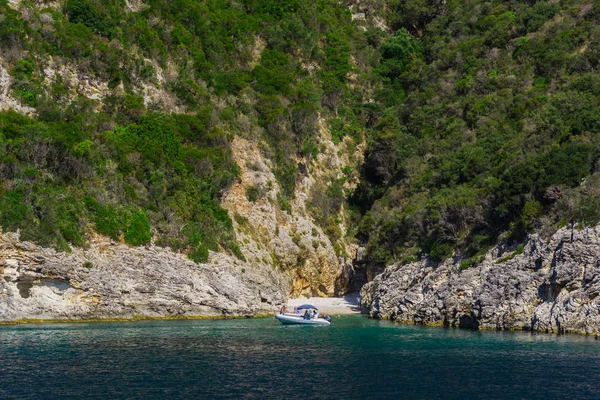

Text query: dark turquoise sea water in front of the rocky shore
(0, 315), (600, 400)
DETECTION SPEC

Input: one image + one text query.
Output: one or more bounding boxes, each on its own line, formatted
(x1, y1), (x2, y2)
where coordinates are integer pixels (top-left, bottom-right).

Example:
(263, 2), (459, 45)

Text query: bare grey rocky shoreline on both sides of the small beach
(7, 222), (600, 335)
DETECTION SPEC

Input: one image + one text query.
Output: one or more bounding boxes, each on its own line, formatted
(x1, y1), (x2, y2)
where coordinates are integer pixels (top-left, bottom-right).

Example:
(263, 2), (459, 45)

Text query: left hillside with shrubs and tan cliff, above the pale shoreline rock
(0, 0), (383, 295)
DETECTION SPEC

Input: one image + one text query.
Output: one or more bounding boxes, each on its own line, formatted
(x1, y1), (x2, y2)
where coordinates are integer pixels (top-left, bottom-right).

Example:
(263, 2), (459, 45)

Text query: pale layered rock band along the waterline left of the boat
(0, 233), (289, 322)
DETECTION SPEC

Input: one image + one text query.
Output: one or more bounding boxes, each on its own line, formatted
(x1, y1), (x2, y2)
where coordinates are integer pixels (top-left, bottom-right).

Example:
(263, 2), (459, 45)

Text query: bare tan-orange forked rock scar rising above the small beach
(222, 127), (356, 297)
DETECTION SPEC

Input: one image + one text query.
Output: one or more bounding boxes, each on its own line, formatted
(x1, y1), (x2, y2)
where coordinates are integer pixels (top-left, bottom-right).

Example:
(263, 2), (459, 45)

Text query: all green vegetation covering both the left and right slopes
(0, 0), (600, 272)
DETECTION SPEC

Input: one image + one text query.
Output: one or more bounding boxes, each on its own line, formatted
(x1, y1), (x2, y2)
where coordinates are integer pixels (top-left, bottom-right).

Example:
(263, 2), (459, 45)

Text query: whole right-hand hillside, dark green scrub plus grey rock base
(352, 0), (600, 335)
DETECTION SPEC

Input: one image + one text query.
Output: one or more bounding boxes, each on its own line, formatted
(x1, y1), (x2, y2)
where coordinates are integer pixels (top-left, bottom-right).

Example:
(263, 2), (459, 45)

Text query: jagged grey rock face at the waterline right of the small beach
(361, 226), (600, 334)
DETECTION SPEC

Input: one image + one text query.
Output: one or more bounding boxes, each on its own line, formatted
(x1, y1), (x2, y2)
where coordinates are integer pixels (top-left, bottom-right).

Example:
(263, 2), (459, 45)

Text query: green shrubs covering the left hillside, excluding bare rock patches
(0, 0), (382, 261)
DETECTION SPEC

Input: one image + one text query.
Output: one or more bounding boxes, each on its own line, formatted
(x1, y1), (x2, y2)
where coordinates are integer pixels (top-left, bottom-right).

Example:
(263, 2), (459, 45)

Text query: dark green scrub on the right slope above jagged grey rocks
(352, 0), (600, 266)
